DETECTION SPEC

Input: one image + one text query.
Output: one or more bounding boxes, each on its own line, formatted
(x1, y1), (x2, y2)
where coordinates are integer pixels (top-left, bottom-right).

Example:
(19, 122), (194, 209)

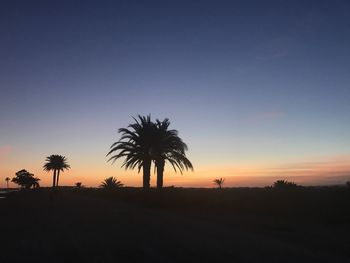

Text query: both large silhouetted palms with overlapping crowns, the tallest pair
(107, 115), (193, 189)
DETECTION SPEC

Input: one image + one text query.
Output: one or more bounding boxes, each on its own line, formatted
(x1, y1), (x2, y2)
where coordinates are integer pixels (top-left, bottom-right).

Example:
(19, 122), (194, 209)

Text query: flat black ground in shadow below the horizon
(0, 188), (350, 262)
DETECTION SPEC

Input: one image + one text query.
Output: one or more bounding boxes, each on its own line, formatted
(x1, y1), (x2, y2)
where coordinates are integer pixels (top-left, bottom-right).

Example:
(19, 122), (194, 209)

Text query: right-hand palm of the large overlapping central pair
(152, 119), (193, 189)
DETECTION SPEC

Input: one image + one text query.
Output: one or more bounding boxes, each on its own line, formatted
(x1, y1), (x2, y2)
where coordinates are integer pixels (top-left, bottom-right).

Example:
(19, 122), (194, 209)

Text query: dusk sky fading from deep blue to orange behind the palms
(0, 0), (350, 187)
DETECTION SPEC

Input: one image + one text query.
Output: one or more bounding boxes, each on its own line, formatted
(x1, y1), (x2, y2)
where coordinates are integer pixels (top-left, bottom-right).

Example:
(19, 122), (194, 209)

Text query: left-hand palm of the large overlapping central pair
(107, 115), (156, 189)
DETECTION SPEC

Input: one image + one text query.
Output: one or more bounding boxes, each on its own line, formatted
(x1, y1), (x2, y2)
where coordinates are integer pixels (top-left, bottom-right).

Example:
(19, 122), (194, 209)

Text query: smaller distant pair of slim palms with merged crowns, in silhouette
(43, 154), (70, 187)
